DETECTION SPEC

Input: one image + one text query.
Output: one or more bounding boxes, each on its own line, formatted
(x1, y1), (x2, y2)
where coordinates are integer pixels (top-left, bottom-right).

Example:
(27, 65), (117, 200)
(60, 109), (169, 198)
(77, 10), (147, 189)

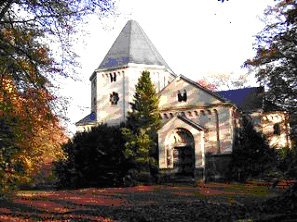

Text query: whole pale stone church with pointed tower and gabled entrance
(76, 20), (290, 178)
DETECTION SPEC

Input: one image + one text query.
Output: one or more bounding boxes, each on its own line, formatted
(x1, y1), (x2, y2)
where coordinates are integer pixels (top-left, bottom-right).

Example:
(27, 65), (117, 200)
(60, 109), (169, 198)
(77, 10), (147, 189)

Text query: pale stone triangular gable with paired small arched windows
(159, 76), (225, 110)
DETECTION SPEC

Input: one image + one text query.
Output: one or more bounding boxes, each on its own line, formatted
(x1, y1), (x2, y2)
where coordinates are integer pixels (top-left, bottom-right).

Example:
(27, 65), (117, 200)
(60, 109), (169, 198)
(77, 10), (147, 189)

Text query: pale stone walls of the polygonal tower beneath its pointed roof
(91, 64), (174, 125)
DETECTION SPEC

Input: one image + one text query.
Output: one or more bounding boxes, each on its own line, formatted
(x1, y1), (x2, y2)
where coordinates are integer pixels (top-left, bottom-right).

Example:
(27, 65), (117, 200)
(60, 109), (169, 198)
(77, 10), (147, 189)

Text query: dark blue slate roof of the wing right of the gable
(216, 87), (281, 112)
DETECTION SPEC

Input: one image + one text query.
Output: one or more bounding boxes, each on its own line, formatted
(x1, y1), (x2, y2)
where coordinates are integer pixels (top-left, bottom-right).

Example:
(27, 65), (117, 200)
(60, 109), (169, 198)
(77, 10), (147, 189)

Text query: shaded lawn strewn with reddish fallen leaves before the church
(0, 181), (297, 222)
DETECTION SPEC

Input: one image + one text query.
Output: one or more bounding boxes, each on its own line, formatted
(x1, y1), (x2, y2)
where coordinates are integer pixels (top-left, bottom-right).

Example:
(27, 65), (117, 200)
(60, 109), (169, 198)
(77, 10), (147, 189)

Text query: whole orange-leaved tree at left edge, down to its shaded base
(0, 76), (67, 192)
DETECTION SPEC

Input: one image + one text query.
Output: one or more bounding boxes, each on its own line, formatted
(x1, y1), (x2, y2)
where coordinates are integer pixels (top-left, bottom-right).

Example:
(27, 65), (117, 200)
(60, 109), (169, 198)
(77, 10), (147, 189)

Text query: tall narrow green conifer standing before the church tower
(123, 71), (160, 182)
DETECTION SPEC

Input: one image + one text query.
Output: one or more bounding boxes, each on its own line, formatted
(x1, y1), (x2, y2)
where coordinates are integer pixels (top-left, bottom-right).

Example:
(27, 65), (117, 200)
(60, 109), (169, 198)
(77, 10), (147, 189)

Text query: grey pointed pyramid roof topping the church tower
(97, 20), (173, 73)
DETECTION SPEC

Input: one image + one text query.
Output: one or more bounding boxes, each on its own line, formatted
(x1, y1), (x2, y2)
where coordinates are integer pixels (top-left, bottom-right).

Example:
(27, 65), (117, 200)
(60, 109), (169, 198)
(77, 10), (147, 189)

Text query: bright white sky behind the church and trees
(61, 0), (274, 133)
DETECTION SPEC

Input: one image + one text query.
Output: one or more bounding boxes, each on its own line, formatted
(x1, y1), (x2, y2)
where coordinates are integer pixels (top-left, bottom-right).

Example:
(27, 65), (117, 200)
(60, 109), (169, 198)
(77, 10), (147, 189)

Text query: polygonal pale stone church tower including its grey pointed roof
(76, 20), (176, 131)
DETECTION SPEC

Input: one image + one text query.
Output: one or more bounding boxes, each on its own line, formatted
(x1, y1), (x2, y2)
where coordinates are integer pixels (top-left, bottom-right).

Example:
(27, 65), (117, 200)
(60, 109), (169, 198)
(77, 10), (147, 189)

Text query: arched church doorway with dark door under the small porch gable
(166, 128), (195, 176)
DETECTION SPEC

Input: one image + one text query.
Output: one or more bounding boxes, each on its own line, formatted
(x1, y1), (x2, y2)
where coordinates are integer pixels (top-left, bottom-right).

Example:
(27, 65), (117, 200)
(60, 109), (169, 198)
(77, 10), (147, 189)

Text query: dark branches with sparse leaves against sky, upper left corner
(0, 0), (113, 92)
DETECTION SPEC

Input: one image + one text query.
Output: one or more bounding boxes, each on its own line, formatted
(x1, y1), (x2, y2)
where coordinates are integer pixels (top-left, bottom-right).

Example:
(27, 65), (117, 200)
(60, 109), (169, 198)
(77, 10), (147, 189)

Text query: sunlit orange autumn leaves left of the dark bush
(0, 75), (67, 177)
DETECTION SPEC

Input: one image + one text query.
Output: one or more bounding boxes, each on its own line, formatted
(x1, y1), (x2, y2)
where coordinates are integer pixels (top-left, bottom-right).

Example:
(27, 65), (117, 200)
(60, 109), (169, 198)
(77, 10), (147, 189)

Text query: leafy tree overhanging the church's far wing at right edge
(244, 0), (297, 142)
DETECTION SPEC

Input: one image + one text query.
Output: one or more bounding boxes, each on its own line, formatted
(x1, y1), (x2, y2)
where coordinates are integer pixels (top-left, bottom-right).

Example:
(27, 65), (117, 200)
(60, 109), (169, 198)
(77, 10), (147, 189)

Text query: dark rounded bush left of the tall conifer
(55, 125), (133, 188)
